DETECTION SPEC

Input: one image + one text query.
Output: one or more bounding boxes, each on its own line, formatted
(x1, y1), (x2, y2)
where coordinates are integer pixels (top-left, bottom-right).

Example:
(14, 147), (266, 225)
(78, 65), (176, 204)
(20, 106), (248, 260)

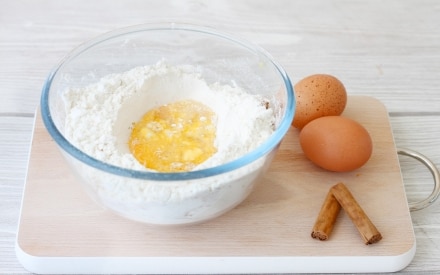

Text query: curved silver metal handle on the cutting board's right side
(397, 148), (440, 211)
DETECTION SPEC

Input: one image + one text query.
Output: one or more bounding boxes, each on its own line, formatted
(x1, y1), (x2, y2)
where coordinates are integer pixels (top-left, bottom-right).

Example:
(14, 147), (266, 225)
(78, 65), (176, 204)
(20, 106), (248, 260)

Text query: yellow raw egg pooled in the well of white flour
(128, 100), (217, 172)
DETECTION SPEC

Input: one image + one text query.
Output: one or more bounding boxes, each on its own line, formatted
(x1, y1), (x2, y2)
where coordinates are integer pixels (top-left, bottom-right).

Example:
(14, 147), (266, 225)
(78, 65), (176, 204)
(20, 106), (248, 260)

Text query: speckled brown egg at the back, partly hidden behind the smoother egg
(292, 74), (347, 129)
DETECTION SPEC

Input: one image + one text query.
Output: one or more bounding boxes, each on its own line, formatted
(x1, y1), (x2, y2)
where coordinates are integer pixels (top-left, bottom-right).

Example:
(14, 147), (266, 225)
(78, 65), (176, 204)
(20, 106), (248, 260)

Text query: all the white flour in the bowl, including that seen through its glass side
(64, 62), (279, 224)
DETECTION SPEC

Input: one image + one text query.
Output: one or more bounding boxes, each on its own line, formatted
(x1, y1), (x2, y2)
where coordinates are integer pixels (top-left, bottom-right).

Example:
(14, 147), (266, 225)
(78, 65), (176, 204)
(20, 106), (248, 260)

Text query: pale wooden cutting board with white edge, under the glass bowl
(16, 96), (415, 274)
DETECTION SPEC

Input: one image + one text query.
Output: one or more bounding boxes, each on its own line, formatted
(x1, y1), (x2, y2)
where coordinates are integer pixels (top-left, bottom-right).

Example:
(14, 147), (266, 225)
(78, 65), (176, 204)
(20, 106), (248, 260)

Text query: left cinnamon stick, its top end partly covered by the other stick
(311, 191), (341, 241)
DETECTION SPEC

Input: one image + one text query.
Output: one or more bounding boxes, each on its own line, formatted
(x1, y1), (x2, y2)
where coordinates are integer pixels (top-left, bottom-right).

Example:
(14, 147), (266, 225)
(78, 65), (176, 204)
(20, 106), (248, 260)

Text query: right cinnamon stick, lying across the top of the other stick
(330, 183), (382, 244)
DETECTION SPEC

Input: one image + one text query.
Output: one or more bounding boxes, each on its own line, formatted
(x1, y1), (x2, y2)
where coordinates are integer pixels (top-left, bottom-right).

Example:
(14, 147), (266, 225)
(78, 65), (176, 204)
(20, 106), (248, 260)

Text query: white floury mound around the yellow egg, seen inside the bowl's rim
(64, 62), (275, 170)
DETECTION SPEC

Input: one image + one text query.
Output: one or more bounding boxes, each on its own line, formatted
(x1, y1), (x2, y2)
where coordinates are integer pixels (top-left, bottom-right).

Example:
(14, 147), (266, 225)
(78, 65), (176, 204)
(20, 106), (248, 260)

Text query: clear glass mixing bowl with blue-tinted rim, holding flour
(41, 23), (295, 225)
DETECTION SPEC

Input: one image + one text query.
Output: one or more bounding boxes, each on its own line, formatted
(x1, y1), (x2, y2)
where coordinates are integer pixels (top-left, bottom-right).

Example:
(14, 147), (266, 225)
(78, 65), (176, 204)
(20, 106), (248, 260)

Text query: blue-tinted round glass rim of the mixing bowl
(40, 22), (295, 181)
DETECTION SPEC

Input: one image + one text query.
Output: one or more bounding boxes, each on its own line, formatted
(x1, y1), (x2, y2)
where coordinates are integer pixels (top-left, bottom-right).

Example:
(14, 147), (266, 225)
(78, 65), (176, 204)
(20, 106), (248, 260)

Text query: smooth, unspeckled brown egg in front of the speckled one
(299, 116), (373, 172)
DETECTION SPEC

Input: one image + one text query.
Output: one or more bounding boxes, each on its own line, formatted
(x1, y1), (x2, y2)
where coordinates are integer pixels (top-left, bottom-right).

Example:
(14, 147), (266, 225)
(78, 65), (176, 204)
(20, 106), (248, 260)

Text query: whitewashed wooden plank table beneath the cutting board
(0, 0), (440, 274)
